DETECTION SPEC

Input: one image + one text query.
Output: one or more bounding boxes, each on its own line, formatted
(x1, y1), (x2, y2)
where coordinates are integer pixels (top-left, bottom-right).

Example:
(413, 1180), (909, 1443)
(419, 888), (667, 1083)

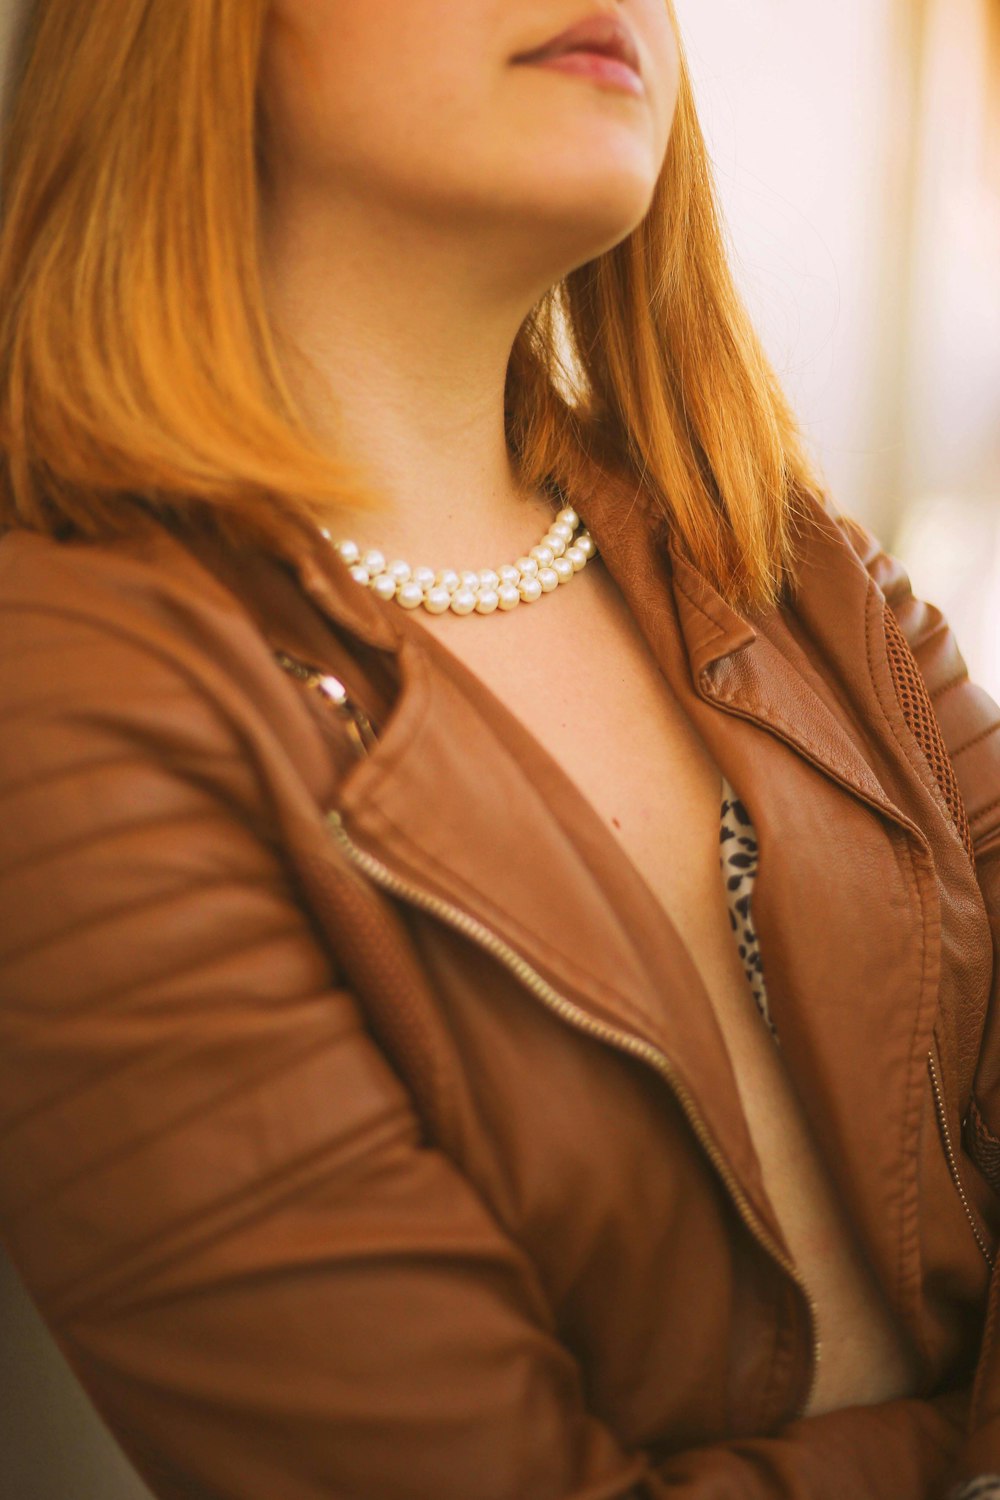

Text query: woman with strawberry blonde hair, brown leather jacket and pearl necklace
(0, 0), (1000, 1500)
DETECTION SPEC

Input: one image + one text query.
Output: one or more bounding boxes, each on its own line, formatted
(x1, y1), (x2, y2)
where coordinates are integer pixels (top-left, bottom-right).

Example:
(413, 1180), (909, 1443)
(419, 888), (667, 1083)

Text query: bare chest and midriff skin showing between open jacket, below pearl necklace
(401, 563), (910, 1409)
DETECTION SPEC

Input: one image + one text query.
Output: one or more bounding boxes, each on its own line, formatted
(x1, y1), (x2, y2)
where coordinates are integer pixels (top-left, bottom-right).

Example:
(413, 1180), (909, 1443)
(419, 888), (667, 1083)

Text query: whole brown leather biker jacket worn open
(0, 485), (1000, 1500)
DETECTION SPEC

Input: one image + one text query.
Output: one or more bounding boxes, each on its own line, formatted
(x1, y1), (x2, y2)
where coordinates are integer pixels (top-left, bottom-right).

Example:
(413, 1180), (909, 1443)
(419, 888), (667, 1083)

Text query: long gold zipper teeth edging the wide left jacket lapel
(327, 810), (820, 1416)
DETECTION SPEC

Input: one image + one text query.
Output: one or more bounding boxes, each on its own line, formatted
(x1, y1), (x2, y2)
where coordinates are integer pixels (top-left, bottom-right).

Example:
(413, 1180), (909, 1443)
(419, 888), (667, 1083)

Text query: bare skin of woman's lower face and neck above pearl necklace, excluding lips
(261, 0), (678, 567)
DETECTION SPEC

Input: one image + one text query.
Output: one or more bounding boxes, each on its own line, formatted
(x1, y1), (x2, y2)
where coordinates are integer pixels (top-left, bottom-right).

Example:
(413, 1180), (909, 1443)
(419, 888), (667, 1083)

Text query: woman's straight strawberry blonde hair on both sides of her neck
(0, 0), (819, 608)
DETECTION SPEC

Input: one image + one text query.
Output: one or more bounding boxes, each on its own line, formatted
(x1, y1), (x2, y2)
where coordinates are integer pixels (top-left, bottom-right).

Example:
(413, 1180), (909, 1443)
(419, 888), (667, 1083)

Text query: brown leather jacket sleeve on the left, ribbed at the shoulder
(0, 591), (963, 1500)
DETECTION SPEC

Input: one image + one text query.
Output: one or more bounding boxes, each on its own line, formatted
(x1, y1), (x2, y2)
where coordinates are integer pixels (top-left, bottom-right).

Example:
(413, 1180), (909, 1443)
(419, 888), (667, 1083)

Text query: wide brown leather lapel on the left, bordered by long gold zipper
(280, 516), (781, 1239)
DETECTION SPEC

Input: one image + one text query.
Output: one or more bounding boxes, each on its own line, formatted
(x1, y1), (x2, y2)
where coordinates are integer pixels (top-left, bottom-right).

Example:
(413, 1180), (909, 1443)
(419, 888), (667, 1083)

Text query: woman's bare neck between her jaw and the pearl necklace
(262, 183), (558, 569)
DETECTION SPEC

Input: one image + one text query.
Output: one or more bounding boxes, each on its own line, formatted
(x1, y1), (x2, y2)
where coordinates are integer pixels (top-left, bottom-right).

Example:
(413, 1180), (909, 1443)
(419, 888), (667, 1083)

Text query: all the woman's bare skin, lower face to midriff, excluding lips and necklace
(259, 0), (913, 1412)
